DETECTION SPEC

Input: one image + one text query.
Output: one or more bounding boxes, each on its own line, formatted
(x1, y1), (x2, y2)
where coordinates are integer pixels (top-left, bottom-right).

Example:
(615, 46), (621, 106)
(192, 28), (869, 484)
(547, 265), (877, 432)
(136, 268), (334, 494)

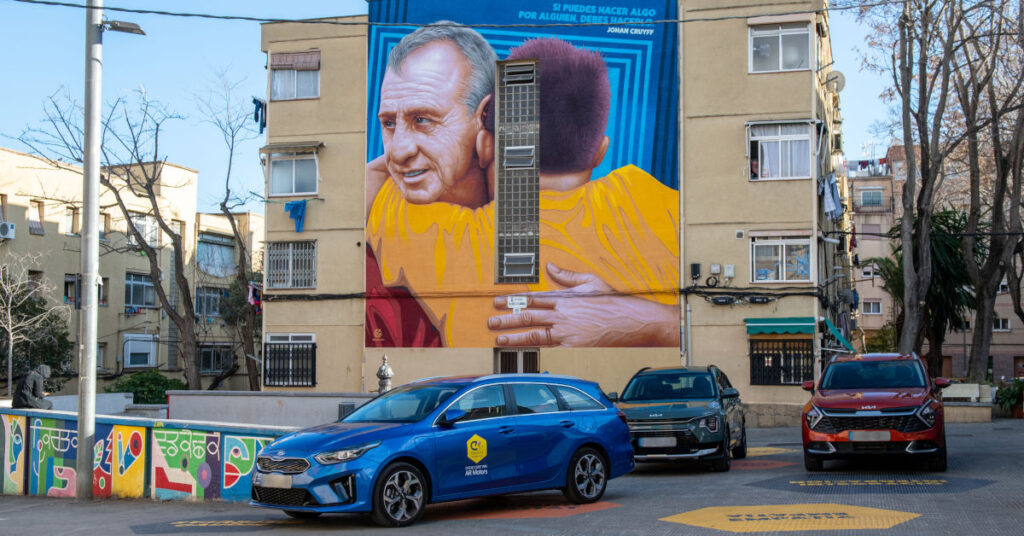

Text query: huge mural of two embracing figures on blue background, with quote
(366, 0), (680, 347)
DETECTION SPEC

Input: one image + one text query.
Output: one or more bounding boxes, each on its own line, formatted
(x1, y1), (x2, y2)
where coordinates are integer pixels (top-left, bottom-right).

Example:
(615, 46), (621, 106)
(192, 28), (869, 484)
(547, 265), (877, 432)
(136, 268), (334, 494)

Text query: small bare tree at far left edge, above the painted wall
(0, 252), (71, 397)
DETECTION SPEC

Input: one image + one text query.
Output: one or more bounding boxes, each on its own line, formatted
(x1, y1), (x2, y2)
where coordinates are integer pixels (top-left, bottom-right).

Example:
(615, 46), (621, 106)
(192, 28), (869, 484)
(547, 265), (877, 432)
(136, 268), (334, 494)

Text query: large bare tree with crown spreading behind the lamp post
(18, 90), (202, 389)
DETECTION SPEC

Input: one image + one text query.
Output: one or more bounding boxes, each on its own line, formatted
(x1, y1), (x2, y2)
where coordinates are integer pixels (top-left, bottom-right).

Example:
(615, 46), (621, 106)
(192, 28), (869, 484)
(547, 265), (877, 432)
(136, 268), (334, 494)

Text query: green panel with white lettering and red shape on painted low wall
(152, 428), (222, 500)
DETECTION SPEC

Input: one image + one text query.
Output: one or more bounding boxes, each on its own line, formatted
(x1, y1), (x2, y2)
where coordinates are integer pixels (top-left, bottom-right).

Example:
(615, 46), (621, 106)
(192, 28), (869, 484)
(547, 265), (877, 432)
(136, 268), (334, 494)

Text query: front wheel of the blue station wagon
(371, 462), (427, 527)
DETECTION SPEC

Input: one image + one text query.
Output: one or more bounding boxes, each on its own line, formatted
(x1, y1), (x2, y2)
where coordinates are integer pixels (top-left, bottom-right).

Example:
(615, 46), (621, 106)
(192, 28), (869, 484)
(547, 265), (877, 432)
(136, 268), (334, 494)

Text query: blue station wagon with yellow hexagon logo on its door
(252, 374), (633, 527)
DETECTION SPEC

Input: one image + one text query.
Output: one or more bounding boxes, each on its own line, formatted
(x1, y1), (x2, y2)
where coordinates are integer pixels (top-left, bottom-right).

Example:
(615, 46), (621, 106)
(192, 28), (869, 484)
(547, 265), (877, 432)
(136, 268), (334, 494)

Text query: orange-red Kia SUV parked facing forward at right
(801, 354), (949, 471)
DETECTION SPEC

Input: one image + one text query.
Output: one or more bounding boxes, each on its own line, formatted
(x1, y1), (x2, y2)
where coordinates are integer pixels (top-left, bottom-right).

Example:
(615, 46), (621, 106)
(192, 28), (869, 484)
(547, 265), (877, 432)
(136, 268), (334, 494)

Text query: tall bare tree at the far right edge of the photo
(954, 0), (1024, 381)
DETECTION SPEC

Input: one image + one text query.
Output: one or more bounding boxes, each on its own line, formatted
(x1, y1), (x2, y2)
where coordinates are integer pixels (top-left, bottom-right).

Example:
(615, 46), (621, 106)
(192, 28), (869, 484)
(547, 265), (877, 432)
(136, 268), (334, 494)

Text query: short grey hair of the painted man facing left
(387, 20), (498, 113)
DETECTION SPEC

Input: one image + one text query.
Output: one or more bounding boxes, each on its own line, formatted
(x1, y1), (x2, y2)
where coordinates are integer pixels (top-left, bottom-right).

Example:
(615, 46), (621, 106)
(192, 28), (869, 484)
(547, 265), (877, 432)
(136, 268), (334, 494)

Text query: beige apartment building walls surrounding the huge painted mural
(261, 0), (852, 424)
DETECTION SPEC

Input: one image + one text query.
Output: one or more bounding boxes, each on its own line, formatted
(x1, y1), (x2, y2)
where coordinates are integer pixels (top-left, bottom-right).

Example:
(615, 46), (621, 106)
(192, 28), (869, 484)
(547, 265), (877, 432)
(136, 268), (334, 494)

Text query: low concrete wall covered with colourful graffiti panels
(0, 408), (292, 501)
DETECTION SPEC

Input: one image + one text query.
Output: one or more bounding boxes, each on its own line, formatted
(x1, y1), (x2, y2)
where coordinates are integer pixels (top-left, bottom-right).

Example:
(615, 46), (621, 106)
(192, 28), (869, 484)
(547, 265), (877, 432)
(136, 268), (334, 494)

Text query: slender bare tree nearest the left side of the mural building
(197, 72), (260, 390)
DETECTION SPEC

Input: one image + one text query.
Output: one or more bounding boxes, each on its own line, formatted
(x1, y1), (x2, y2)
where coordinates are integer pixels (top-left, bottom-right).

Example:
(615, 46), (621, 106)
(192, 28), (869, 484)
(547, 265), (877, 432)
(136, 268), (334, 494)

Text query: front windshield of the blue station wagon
(341, 383), (465, 422)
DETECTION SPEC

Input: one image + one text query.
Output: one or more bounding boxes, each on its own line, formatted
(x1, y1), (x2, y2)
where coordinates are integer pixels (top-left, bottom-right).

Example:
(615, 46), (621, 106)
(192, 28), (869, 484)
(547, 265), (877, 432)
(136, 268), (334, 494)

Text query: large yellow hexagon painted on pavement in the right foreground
(660, 503), (921, 532)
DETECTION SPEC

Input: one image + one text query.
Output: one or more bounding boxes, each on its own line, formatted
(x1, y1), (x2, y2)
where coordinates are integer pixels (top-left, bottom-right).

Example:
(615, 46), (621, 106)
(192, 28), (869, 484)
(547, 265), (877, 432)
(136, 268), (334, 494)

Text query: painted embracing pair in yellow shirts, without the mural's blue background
(367, 2), (679, 347)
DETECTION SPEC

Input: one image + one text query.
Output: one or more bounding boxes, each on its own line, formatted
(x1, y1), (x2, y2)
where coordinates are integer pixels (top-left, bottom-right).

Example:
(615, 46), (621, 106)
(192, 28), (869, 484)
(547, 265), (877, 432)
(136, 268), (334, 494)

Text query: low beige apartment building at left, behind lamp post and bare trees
(0, 148), (256, 394)
